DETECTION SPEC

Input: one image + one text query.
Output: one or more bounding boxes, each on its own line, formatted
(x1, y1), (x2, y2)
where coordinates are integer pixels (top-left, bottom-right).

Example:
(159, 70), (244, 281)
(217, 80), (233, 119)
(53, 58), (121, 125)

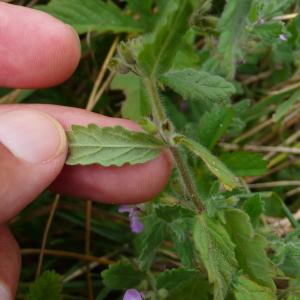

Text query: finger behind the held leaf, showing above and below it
(0, 105), (172, 203)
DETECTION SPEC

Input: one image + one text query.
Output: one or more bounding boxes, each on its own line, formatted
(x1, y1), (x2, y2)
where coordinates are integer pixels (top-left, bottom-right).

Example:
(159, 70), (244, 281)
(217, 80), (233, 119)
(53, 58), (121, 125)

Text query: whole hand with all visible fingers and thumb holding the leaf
(0, 3), (172, 300)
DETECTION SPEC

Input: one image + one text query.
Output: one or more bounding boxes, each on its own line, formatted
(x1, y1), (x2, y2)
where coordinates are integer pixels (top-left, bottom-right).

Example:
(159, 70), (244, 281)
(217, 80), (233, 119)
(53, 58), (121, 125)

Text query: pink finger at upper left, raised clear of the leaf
(0, 2), (80, 88)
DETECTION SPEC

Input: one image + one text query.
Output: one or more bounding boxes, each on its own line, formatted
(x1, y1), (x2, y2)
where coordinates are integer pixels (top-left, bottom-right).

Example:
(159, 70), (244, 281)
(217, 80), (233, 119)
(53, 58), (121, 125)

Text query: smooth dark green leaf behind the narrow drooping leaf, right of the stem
(220, 151), (268, 176)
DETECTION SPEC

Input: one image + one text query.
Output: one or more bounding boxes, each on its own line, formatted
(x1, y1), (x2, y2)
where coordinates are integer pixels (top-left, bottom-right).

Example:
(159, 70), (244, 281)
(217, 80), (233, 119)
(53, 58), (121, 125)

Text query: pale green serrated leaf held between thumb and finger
(67, 124), (163, 166)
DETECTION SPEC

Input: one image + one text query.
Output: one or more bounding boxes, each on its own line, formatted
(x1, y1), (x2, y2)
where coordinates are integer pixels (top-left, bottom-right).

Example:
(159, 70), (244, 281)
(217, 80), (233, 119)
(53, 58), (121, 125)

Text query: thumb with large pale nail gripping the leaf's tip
(0, 109), (67, 223)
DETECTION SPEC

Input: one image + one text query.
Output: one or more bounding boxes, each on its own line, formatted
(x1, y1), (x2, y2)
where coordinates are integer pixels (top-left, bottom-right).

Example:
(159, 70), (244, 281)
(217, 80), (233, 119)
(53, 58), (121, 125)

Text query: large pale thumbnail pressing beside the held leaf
(0, 110), (67, 163)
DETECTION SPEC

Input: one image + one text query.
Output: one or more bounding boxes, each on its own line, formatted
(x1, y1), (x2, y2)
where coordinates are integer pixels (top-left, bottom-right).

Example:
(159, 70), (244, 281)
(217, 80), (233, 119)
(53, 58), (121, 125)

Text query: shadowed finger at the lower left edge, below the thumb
(0, 225), (21, 300)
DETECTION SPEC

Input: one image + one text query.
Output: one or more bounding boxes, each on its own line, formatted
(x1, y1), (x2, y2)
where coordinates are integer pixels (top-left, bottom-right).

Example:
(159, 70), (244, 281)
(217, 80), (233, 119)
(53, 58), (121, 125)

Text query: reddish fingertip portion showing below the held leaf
(52, 151), (172, 204)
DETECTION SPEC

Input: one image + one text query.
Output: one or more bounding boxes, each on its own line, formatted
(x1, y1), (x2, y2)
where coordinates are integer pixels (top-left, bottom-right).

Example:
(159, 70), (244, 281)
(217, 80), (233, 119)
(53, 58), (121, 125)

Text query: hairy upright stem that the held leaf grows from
(144, 77), (204, 212)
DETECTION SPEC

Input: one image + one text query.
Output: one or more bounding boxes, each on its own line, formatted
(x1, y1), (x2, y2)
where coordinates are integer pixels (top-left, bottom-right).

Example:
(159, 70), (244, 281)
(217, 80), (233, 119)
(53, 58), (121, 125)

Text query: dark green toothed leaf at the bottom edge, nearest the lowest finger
(25, 271), (63, 300)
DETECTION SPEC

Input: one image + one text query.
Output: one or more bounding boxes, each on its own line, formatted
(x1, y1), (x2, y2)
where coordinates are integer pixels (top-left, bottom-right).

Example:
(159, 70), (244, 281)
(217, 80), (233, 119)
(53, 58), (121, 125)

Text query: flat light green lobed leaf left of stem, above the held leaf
(110, 73), (151, 121)
